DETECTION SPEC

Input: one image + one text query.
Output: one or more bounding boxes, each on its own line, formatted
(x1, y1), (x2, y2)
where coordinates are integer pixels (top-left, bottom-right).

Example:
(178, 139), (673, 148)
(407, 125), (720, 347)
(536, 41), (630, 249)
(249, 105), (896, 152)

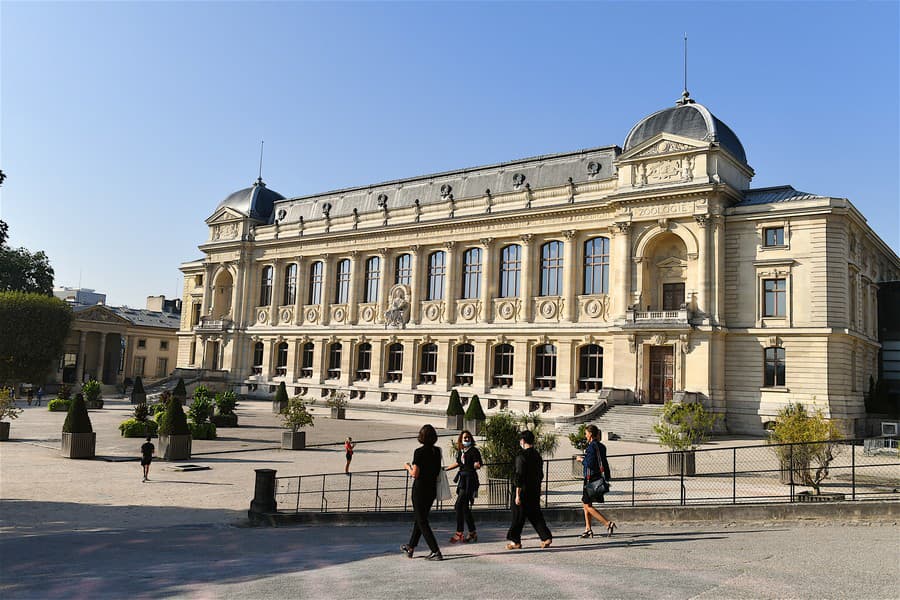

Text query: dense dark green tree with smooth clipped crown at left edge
(0, 292), (73, 384)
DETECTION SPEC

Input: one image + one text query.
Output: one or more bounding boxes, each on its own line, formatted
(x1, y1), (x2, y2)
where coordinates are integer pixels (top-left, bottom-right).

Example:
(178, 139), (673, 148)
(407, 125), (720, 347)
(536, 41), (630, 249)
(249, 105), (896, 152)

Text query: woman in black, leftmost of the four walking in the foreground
(400, 425), (444, 560)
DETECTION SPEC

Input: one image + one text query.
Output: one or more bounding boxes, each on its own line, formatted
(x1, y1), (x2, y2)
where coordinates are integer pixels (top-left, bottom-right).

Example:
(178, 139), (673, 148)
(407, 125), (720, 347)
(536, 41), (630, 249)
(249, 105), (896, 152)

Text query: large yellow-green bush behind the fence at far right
(768, 398), (843, 501)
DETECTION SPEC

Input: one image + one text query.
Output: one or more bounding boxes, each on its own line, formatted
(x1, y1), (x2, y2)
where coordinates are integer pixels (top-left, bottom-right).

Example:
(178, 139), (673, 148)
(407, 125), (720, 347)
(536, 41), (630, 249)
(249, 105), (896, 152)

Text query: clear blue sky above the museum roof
(0, 1), (900, 306)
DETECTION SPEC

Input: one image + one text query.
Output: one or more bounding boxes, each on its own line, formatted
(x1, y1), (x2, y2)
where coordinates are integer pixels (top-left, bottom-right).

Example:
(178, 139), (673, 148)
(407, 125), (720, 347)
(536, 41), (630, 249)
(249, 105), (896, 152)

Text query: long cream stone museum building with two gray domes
(177, 92), (900, 434)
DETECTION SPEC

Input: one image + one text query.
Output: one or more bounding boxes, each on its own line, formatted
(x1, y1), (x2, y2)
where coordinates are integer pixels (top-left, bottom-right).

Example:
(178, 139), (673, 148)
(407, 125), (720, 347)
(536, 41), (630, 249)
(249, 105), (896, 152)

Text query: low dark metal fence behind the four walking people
(275, 439), (900, 512)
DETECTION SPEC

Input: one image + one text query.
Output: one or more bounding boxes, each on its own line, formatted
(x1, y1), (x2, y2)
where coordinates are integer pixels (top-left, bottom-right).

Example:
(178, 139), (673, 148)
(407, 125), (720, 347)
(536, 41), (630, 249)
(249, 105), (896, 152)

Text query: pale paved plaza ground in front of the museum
(0, 398), (900, 599)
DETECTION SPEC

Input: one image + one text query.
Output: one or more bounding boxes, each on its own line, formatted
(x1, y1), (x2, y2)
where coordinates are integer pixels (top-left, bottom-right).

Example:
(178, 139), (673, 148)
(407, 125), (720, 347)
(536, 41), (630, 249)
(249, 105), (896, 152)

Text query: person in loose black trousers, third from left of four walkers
(506, 429), (553, 550)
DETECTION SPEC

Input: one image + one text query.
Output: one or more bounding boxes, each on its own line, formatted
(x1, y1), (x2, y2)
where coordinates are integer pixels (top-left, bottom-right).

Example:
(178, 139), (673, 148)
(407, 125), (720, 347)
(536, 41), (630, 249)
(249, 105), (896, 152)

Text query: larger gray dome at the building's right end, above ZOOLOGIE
(624, 97), (747, 164)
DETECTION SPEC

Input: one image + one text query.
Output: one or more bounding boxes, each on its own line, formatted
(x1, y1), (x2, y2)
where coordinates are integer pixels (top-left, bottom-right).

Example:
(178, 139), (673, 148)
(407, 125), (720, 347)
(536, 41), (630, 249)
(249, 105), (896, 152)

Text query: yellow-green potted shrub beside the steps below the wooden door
(653, 400), (719, 475)
